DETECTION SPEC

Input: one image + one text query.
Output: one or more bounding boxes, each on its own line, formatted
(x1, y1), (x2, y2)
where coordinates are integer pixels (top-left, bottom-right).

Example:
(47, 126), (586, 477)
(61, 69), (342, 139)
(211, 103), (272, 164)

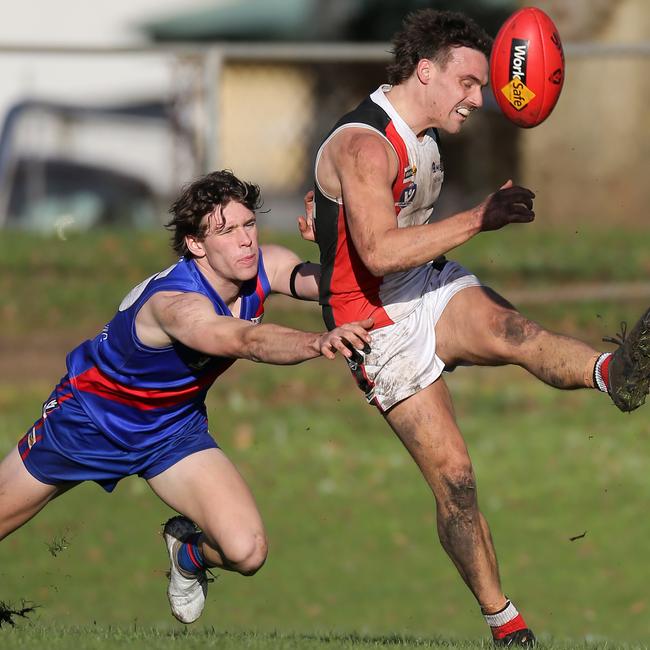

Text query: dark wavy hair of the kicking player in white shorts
(386, 9), (492, 86)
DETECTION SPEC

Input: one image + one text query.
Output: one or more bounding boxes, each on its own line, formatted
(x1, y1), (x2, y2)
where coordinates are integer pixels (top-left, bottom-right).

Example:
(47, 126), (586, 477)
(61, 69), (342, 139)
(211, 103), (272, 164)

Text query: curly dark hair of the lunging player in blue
(165, 169), (262, 256)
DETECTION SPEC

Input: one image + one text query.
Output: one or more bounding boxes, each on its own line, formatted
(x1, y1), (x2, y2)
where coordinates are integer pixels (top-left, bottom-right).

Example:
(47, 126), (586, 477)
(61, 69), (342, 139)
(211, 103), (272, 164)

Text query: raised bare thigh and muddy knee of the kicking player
(436, 287), (543, 365)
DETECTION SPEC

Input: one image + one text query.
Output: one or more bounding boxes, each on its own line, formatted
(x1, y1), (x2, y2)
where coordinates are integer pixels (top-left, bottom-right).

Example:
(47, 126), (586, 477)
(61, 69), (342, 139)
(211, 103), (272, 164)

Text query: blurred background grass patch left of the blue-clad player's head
(0, 231), (174, 337)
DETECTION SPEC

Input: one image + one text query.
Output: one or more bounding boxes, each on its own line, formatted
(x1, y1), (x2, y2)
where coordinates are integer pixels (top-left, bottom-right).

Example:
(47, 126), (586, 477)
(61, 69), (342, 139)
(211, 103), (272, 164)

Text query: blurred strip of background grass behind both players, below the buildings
(0, 226), (650, 336)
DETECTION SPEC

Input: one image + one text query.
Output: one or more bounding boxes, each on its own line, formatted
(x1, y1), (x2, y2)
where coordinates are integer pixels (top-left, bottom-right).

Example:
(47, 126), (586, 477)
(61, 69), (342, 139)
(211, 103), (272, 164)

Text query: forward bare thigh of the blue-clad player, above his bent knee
(149, 449), (265, 550)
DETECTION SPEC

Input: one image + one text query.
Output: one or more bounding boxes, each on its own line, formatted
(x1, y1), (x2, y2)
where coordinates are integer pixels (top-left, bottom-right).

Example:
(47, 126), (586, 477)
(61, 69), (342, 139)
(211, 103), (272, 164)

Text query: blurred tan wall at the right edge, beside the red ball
(519, 0), (650, 225)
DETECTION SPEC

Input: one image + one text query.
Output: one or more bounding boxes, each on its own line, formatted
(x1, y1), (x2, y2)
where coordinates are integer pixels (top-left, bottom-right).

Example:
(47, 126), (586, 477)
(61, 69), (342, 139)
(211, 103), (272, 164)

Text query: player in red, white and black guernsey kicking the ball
(308, 9), (650, 646)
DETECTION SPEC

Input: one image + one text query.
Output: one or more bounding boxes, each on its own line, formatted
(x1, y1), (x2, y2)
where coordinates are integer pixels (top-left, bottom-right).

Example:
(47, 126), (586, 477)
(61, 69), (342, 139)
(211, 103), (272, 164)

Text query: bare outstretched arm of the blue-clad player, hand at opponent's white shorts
(138, 292), (372, 365)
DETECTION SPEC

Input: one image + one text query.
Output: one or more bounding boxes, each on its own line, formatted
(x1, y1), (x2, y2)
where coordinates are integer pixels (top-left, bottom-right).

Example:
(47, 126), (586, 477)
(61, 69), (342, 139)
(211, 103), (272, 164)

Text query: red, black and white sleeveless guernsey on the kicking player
(314, 85), (444, 329)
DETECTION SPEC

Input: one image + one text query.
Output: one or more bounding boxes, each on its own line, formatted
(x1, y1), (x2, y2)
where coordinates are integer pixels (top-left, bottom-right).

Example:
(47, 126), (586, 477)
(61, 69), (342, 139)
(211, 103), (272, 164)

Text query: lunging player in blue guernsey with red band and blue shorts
(0, 171), (372, 623)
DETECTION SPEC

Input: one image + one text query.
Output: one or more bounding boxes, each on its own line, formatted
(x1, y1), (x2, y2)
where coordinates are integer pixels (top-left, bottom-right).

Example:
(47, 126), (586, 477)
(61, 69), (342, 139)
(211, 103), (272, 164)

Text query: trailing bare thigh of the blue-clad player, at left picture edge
(0, 447), (74, 539)
